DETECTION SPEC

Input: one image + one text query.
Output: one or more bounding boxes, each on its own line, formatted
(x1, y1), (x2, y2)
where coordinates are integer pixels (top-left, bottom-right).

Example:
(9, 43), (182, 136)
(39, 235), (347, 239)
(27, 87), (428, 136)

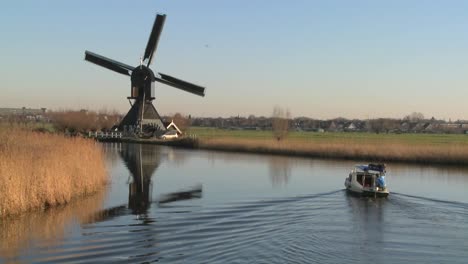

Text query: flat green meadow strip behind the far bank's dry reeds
(188, 127), (468, 146)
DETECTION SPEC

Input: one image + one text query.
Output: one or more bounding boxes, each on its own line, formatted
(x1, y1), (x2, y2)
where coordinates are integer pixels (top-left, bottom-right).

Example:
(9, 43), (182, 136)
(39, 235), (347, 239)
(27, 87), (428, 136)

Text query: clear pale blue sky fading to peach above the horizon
(0, 0), (468, 120)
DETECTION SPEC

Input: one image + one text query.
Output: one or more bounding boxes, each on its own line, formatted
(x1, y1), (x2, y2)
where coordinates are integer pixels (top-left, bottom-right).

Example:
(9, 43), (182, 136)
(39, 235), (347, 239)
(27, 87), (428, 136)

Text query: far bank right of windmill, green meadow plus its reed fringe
(189, 128), (468, 165)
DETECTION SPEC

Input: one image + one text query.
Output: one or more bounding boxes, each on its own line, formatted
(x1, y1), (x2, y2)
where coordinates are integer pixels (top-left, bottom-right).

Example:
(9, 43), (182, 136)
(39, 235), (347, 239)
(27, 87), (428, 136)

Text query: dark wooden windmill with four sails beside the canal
(85, 14), (205, 134)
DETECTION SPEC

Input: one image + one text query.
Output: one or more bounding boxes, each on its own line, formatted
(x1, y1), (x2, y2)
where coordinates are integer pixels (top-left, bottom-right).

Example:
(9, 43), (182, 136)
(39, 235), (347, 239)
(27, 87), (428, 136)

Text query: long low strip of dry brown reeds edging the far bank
(199, 138), (468, 165)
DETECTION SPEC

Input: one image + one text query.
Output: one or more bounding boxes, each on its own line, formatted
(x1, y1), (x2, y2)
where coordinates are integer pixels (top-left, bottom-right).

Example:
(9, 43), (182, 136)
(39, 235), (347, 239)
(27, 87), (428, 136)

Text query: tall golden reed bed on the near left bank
(0, 126), (107, 216)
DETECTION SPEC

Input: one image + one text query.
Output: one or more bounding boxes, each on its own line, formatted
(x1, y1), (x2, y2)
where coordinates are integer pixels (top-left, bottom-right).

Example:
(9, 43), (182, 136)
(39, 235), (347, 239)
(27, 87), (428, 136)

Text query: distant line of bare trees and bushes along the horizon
(0, 109), (468, 134)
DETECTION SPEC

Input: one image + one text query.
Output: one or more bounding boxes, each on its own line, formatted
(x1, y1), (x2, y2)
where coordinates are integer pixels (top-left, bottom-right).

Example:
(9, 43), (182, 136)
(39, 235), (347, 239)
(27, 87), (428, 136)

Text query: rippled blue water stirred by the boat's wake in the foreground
(3, 191), (468, 263)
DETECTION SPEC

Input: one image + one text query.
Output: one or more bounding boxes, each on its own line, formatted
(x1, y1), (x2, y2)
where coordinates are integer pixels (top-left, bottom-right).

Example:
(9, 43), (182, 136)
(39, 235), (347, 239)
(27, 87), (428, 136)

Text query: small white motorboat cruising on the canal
(344, 164), (390, 197)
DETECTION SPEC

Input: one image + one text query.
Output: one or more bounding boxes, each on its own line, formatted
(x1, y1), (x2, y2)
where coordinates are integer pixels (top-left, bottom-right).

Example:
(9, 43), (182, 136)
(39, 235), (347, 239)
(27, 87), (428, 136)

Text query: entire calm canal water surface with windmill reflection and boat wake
(0, 143), (468, 263)
